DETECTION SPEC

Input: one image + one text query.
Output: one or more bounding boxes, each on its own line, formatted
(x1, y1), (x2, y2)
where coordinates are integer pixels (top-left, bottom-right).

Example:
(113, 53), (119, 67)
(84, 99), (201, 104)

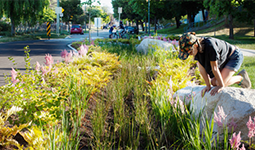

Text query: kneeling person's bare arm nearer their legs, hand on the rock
(210, 61), (225, 95)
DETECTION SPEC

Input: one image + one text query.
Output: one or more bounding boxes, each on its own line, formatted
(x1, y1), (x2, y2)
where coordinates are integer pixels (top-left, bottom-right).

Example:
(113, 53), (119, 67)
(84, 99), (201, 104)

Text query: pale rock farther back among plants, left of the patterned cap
(136, 38), (176, 54)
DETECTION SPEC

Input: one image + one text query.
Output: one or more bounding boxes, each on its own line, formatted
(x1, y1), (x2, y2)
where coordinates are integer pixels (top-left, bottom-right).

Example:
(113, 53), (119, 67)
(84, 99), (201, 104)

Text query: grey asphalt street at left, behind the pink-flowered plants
(0, 30), (109, 86)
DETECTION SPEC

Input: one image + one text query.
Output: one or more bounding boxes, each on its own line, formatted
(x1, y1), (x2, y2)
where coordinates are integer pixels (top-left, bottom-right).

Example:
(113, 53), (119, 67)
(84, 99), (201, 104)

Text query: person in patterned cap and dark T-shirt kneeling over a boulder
(178, 32), (251, 96)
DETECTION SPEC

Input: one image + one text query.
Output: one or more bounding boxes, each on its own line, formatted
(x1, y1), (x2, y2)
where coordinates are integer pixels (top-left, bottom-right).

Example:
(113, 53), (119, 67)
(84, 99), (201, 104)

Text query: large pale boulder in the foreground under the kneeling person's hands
(174, 86), (255, 140)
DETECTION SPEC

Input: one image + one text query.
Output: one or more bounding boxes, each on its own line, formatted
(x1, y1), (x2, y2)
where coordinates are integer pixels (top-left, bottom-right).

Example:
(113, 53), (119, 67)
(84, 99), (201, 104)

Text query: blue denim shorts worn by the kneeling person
(224, 49), (243, 72)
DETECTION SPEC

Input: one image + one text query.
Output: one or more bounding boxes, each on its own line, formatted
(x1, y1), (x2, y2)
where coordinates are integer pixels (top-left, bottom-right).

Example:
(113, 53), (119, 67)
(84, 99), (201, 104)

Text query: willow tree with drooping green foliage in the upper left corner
(0, 0), (49, 35)
